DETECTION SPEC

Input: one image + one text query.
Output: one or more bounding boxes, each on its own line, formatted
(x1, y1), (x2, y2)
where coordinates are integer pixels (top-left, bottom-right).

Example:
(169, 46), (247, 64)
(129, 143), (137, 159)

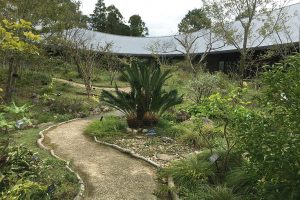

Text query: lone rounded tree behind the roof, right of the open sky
(178, 8), (211, 33)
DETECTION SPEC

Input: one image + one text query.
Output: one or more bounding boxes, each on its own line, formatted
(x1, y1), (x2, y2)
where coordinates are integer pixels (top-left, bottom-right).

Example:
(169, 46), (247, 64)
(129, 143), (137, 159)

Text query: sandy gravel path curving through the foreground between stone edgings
(44, 115), (157, 200)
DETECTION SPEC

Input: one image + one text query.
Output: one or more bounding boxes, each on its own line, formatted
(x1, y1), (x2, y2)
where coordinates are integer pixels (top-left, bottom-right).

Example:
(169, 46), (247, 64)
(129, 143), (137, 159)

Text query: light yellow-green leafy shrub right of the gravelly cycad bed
(189, 89), (249, 177)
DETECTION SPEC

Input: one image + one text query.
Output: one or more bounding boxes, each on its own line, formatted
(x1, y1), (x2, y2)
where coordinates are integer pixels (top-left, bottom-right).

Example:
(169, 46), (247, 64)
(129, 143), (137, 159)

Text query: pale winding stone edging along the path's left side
(37, 118), (85, 200)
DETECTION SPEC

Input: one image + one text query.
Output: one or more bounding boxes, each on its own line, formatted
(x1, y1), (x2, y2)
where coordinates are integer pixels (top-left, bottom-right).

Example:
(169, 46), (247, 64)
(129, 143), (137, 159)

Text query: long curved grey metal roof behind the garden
(67, 3), (300, 56)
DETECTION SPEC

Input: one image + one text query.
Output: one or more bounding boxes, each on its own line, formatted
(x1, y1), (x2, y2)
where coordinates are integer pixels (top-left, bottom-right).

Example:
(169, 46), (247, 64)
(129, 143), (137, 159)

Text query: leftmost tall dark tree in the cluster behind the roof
(90, 0), (107, 32)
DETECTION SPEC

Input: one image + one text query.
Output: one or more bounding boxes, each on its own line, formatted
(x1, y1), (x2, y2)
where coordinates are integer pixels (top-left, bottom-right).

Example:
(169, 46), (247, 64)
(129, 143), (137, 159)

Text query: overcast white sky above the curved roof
(81, 0), (300, 36)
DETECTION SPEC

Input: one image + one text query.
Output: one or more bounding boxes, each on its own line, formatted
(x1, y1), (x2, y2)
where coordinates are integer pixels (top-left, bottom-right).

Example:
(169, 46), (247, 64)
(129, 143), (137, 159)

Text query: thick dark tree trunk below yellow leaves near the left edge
(4, 58), (18, 103)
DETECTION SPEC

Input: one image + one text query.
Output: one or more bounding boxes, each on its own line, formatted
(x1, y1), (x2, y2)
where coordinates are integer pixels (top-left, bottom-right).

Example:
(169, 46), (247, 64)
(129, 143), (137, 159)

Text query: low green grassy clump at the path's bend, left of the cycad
(84, 116), (126, 139)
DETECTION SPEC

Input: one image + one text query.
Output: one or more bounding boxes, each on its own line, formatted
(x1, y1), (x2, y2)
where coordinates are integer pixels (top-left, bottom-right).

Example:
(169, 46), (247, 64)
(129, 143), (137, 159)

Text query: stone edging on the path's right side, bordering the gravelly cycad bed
(94, 136), (179, 200)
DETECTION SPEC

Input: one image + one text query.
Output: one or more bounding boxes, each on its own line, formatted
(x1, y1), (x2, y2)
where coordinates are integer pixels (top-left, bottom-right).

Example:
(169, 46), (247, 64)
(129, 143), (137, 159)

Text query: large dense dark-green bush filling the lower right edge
(233, 54), (300, 199)
